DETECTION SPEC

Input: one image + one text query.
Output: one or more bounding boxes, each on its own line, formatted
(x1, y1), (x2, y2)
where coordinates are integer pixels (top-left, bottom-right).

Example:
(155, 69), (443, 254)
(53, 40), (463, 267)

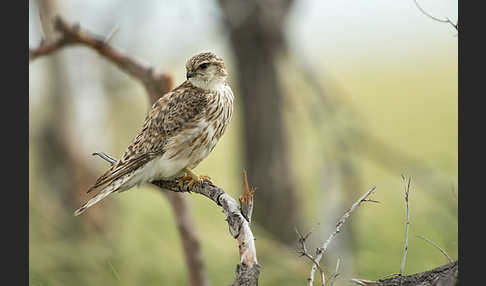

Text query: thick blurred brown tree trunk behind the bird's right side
(220, 1), (299, 243)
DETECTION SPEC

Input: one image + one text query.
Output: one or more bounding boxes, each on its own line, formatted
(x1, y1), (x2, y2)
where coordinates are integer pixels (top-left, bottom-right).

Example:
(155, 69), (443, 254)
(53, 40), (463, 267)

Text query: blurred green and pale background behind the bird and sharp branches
(29, 0), (458, 286)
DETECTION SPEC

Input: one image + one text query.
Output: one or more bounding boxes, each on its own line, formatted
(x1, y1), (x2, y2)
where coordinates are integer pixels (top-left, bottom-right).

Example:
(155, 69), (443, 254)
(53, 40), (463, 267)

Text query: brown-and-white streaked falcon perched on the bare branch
(74, 52), (234, 216)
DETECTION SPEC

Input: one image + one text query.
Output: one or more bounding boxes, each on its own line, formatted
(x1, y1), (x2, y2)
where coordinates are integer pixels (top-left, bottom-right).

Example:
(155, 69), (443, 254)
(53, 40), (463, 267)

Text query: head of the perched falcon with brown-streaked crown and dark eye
(186, 52), (228, 90)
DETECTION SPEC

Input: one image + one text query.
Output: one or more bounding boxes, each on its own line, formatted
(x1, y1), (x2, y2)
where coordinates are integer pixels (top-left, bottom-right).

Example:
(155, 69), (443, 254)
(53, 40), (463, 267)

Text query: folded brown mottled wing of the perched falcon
(88, 81), (208, 193)
